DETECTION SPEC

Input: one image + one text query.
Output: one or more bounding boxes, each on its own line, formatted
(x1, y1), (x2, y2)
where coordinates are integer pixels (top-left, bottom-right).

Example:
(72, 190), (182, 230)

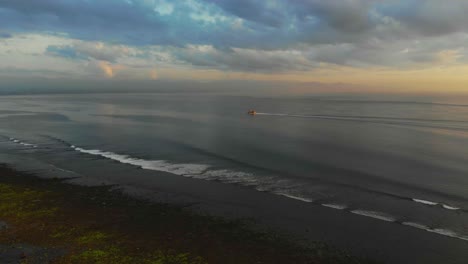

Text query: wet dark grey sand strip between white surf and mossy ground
(65, 164), (468, 264)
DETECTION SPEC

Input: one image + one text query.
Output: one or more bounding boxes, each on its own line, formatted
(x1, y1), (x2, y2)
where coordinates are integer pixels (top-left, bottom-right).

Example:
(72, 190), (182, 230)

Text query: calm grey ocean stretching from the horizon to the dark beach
(0, 92), (468, 263)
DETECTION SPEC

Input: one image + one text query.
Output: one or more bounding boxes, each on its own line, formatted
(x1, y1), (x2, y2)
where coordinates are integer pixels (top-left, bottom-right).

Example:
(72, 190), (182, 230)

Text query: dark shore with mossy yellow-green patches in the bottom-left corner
(0, 166), (377, 264)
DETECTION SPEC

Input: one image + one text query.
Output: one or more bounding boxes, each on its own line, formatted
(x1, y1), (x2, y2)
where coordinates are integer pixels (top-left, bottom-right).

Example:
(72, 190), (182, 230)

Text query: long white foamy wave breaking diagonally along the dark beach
(69, 145), (468, 241)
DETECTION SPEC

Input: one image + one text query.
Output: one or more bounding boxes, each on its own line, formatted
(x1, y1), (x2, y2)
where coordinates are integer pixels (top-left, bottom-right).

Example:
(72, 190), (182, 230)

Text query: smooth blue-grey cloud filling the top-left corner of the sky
(0, 0), (164, 43)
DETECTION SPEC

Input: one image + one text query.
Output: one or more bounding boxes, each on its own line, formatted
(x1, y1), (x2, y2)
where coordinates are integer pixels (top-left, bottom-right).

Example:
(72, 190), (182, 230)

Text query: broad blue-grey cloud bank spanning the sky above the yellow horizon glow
(0, 0), (468, 72)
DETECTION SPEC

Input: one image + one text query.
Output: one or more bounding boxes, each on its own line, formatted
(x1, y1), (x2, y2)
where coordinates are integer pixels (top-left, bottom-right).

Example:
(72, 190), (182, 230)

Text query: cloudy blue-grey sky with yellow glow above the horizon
(0, 0), (468, 93)
